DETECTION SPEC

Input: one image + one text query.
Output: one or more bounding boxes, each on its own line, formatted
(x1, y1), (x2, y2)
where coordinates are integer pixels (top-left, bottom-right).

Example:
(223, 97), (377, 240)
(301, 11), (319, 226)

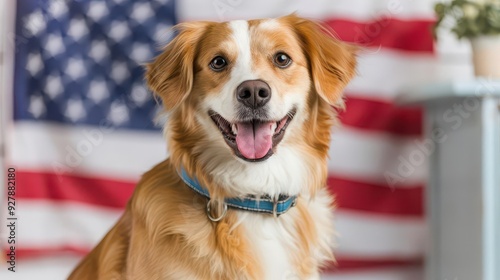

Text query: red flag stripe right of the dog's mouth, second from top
(339, 93), (422, 136)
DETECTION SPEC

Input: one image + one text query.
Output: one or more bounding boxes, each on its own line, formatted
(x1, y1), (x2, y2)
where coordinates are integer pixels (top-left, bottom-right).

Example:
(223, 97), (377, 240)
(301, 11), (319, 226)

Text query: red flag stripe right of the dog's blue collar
(328, 177), (424, 216)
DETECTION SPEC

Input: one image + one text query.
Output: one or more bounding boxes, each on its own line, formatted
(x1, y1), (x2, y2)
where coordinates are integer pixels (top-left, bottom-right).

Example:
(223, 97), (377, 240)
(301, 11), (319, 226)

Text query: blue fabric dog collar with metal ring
(179, 168), (297, 221)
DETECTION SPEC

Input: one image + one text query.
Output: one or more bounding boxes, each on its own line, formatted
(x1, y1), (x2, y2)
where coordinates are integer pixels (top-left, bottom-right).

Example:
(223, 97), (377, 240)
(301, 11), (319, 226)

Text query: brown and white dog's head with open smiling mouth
(146, 15), (355, 197)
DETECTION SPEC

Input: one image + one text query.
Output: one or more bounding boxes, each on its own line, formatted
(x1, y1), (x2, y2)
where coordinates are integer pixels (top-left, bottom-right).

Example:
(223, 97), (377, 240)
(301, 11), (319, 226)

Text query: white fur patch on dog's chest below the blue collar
(240, 212), (295, 280)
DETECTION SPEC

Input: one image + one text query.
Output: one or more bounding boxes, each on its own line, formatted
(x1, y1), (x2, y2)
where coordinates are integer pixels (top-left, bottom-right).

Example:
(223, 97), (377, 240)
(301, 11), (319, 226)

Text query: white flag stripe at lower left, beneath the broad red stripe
(12, 199), (123, 250)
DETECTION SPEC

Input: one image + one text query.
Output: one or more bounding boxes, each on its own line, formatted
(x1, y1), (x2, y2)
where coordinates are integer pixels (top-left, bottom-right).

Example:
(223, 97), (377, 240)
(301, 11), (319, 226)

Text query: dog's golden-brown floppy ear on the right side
(283, 14), (358, 106)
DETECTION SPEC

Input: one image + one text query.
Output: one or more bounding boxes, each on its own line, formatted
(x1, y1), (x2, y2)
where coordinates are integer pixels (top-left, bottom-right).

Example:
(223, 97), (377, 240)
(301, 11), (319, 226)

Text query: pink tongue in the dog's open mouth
(236, 122), (274, 159)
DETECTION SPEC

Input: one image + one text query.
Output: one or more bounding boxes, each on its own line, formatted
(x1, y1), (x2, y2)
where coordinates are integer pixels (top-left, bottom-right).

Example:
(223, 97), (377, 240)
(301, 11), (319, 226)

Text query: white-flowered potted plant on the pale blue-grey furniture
(434, 0), (500, 78)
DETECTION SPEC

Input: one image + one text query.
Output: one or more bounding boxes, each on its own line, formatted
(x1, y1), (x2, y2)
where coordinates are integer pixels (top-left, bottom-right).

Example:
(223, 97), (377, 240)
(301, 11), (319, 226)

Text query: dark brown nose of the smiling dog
(236, 80), (271, 109)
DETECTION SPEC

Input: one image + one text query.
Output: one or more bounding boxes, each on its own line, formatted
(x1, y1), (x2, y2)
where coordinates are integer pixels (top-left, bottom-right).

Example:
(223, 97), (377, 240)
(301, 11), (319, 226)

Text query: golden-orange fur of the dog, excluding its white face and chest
(69, 15), (355, 280)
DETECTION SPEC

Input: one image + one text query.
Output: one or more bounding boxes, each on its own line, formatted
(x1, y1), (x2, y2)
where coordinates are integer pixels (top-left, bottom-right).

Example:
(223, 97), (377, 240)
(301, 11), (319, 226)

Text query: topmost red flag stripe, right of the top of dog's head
(324, 17), (434, 52)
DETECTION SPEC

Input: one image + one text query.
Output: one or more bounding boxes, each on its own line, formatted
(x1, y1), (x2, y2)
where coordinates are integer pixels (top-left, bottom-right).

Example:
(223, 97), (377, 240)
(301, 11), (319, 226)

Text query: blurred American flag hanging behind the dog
(0, 0), (467, 280)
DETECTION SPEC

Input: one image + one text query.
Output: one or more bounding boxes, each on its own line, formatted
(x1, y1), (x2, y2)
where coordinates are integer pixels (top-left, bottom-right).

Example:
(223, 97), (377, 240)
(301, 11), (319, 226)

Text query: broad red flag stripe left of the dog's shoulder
(16, 170), (135, 208)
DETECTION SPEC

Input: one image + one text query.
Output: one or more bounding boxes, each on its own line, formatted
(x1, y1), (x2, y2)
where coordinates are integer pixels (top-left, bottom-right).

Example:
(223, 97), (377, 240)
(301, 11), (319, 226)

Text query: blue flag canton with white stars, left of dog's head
(14, 0), (176, 129)
